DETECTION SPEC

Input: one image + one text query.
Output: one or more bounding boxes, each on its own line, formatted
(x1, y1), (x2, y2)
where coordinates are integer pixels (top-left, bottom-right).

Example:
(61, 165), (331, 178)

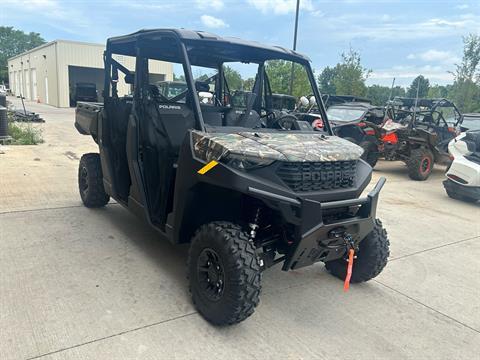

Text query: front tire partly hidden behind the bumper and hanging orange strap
(325, 219), (390, 283)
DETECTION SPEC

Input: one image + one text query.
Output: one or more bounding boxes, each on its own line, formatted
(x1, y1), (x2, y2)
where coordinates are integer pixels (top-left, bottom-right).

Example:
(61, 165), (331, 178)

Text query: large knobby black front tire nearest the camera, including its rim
(188, 222), (262, 325)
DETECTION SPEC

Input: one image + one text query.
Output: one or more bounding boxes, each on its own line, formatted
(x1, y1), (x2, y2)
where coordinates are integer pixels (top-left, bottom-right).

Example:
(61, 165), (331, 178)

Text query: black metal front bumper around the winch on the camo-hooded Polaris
(282, 177), (386, 271)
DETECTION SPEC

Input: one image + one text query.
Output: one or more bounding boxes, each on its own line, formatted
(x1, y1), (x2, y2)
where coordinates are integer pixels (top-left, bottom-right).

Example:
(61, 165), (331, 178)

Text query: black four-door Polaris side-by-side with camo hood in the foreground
(75, 29), (389, 325)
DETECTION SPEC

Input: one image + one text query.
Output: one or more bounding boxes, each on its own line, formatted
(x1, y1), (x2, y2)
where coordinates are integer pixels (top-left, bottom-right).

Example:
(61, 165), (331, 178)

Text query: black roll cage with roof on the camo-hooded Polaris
(103, 29), (333, 134)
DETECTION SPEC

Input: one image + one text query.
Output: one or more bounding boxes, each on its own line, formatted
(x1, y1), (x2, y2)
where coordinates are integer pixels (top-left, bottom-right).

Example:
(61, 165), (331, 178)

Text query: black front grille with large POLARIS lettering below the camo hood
(277, 160), (357, 192)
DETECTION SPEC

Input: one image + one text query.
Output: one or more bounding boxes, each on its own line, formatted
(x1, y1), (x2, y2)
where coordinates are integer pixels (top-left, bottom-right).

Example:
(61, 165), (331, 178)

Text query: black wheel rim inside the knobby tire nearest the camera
(197, 248), (225, 301)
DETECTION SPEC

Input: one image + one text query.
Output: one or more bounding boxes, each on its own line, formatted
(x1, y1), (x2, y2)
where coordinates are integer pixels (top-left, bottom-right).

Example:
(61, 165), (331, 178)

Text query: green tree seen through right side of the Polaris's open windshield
(265, 60), (313, 97)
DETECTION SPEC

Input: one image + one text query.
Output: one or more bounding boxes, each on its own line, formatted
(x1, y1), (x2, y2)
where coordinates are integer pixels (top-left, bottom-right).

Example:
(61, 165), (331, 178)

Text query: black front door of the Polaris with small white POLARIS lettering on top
(129, 59), (194, 231)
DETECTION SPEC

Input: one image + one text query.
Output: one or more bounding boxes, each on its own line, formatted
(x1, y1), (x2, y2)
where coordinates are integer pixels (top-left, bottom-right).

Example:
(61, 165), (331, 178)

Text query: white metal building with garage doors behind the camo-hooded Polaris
(8, 40), (173, 107)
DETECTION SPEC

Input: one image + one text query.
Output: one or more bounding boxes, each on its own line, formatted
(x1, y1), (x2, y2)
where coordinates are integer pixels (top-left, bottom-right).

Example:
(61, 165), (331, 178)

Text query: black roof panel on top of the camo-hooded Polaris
(107, 29), (310, 67)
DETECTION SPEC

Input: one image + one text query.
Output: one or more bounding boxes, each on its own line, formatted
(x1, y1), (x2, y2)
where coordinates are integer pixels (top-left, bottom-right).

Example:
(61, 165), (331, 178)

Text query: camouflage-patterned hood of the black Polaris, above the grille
(192, 130), (363, 162)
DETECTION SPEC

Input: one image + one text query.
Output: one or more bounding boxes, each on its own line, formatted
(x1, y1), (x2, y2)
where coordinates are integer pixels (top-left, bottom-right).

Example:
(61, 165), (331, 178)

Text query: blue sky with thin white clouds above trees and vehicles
(0, 0), (480, 86)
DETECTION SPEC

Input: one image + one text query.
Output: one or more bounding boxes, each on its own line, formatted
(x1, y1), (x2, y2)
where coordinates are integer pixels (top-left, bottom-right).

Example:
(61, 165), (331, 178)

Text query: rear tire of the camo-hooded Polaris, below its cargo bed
(78, 153), (110, 208)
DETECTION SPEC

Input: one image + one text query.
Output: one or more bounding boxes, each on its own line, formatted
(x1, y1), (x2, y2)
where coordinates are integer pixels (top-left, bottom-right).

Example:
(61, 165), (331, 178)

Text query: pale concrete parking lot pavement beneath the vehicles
(0, 99), (480, 359)
